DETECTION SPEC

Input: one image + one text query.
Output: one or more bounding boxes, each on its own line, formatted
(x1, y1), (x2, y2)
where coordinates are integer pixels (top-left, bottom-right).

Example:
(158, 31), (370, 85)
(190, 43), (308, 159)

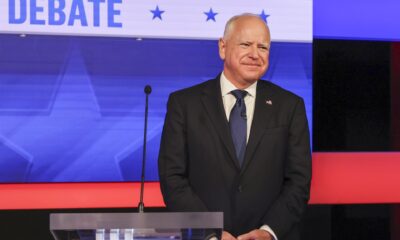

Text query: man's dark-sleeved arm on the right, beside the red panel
(263, 99), (311, 239)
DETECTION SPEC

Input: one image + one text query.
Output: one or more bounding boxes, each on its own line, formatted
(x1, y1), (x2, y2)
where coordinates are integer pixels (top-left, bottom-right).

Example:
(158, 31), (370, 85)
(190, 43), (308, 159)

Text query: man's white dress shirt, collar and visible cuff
(220, 72), (278, 240)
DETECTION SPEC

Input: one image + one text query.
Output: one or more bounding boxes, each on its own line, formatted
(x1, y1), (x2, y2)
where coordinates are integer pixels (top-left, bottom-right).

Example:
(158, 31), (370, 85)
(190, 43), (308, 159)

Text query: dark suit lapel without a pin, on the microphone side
(201, 76), (240, 169)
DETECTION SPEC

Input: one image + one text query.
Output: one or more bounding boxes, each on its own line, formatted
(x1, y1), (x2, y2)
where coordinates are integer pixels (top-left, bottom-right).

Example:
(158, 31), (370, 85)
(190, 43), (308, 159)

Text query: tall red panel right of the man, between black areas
(310, 152), (400, 204)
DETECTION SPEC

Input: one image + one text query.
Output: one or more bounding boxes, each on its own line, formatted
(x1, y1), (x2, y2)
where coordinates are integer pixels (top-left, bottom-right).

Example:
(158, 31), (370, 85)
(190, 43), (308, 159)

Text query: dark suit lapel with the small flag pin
(241, 80), (274, 173)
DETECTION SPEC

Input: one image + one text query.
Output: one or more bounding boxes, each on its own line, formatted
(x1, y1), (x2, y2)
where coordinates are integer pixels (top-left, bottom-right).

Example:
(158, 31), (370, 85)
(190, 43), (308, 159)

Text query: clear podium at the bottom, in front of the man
(50, 212), (223, 240)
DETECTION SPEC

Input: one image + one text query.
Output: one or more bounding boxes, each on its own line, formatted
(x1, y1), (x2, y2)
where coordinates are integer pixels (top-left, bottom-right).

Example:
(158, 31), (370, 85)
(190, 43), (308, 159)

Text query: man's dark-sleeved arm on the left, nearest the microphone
(158, 94), (207, 212)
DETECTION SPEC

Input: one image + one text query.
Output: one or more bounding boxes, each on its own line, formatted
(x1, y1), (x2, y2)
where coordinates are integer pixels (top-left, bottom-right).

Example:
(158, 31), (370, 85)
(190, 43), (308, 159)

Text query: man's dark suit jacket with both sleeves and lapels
(159, 77), (311, 240)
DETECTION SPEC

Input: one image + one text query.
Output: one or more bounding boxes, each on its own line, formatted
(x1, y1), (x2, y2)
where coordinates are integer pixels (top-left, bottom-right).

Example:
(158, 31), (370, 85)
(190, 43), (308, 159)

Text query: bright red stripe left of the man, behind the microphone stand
(0, 182), (164, 209)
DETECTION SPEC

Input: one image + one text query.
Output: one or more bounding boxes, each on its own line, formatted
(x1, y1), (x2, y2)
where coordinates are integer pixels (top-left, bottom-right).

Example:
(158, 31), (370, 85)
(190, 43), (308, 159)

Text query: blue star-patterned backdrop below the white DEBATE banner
(0, 35), (312, 182)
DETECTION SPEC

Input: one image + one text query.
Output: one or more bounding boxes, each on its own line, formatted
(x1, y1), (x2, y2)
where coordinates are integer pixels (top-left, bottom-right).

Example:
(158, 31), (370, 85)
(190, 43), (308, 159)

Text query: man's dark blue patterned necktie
(229, 90), (247, 166)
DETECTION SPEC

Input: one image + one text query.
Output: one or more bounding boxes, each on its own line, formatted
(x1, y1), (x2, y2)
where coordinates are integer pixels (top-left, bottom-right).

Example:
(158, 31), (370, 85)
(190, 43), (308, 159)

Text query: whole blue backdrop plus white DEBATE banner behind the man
(0, 0), (312, 183)
